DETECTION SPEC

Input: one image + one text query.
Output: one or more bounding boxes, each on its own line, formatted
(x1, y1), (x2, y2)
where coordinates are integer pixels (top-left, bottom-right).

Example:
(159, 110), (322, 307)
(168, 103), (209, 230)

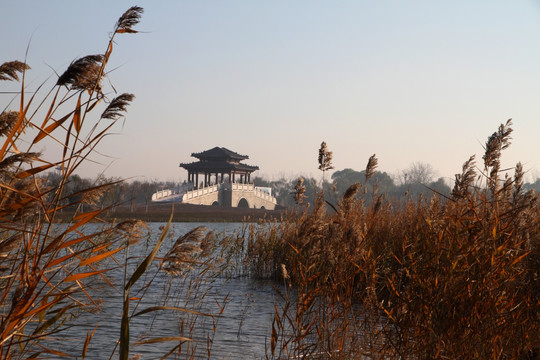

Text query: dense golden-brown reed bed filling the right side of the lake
(248, 121), (540, 359)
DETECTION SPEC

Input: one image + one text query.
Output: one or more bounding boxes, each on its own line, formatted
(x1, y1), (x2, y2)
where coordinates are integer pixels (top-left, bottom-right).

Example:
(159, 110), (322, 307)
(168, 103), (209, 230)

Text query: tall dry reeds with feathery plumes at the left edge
(0, 8), (148, 359)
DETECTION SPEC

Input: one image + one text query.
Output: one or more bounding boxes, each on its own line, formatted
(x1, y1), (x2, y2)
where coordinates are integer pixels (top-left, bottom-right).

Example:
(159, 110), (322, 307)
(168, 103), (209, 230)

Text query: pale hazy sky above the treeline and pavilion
(0, 0), (540, 180)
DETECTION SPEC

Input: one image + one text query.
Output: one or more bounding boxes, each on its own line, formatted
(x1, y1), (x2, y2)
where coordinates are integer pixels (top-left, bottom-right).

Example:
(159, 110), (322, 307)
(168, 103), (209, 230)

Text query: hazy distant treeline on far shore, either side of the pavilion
(48, 163), (540, 207)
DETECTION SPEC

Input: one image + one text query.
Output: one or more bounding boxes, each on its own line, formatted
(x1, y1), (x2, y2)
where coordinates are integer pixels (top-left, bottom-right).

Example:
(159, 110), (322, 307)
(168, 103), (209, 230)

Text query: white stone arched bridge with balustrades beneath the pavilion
(152, 183), (277, 210)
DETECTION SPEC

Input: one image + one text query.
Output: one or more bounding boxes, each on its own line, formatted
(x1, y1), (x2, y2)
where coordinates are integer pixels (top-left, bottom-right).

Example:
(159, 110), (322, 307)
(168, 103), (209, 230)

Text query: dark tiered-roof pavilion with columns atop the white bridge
(180, 146), (259, 189)
